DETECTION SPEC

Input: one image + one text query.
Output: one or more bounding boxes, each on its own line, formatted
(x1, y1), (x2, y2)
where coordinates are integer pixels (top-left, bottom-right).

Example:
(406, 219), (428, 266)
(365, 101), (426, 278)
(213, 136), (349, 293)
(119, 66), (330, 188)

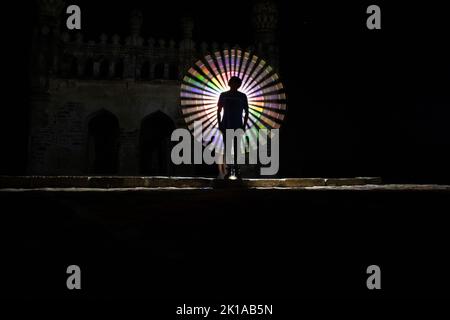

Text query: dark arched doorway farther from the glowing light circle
(88, 110), (120, 174)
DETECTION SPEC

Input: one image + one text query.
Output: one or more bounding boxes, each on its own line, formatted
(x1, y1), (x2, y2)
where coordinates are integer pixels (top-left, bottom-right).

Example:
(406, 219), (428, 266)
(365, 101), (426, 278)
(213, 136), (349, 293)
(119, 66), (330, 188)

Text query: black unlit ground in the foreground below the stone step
(0, 178), (450, 303)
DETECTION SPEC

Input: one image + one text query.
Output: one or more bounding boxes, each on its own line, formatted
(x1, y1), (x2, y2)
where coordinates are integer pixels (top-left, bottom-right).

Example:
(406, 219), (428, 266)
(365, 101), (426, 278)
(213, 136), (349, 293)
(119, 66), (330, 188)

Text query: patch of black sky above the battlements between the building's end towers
(62, 0), (252, 43)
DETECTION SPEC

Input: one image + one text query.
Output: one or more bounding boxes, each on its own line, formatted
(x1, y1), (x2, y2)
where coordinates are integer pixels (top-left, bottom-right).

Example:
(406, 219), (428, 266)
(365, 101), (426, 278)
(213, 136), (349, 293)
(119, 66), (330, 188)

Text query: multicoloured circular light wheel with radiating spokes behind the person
(181, 49), (286, 153)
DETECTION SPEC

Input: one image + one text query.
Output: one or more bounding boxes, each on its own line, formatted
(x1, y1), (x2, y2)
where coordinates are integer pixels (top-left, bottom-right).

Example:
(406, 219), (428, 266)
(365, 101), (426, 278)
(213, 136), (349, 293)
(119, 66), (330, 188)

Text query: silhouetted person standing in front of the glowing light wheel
(217, 77), (248, 178)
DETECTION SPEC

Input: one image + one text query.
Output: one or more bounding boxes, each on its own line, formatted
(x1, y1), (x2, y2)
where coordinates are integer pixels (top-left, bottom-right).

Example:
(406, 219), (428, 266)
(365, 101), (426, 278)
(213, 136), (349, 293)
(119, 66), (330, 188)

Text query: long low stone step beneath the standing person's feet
(0, 176), (381, 189)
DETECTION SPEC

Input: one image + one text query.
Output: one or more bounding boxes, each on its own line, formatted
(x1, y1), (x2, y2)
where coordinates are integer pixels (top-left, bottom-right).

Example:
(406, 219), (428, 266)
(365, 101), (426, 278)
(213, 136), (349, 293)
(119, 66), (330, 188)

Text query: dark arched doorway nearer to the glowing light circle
(140, 111), (175, 176)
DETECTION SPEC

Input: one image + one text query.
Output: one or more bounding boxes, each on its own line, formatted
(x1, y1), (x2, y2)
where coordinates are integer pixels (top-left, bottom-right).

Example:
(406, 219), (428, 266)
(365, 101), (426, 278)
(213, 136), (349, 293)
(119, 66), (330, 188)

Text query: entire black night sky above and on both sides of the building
(2, 0), (450, 182)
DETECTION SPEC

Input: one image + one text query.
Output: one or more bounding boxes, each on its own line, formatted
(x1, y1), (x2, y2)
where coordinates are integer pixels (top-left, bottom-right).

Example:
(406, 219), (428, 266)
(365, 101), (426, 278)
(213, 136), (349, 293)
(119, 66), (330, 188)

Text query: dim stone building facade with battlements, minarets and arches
(28, 0), (278, 175)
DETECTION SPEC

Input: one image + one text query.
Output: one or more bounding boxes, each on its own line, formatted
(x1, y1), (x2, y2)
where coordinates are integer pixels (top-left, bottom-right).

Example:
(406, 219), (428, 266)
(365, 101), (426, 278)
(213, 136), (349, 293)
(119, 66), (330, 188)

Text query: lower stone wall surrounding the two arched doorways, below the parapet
(29, 79), (181, 175)
